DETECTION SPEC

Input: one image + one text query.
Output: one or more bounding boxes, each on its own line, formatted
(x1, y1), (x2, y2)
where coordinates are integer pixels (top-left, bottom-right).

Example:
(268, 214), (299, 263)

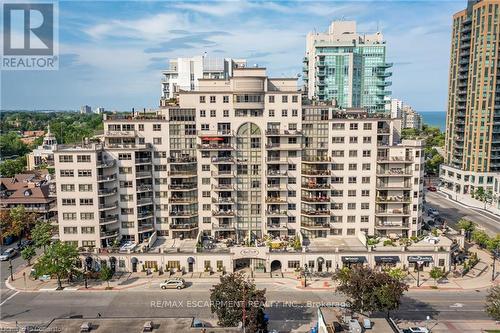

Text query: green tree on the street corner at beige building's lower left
(34, 241), (78, 289)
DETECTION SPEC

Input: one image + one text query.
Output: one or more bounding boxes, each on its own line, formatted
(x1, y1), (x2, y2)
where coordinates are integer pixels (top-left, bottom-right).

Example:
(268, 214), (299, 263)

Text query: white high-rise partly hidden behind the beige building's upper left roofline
(160, 55), (246, 105)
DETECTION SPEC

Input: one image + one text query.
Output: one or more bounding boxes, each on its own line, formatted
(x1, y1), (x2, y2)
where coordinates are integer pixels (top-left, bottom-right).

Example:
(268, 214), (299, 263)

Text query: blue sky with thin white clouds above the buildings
(0, 0), (466, 112)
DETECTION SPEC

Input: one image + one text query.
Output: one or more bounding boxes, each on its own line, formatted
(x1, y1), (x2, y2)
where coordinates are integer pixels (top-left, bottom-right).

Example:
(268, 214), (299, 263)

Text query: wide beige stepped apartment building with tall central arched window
(54, 68), (452, 272)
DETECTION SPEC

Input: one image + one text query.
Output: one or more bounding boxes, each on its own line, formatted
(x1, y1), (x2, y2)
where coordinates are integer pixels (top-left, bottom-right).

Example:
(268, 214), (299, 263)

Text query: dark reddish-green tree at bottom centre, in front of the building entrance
(210, 273), (267, 332)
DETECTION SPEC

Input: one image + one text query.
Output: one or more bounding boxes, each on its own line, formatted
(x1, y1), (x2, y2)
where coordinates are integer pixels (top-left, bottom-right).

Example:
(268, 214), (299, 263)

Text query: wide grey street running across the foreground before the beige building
(0, 280), (488, 330)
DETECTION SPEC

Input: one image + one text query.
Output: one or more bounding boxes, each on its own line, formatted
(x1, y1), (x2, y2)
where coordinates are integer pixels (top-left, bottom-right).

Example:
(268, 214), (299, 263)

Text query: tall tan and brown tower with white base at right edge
(441, 0), (500, 202)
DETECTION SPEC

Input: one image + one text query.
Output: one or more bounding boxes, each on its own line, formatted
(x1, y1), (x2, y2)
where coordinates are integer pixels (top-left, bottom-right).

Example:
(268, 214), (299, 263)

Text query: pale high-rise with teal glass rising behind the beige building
(303, 21), (392, 112)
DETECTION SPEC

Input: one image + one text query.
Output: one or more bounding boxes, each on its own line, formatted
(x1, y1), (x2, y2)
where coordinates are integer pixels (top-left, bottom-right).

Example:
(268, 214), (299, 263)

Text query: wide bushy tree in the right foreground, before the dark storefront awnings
(334, 267), (408, 315)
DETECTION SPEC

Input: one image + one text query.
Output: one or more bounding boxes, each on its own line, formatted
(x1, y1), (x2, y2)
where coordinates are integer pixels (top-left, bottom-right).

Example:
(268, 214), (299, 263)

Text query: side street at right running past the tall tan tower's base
(425, 191), (500, 236)
